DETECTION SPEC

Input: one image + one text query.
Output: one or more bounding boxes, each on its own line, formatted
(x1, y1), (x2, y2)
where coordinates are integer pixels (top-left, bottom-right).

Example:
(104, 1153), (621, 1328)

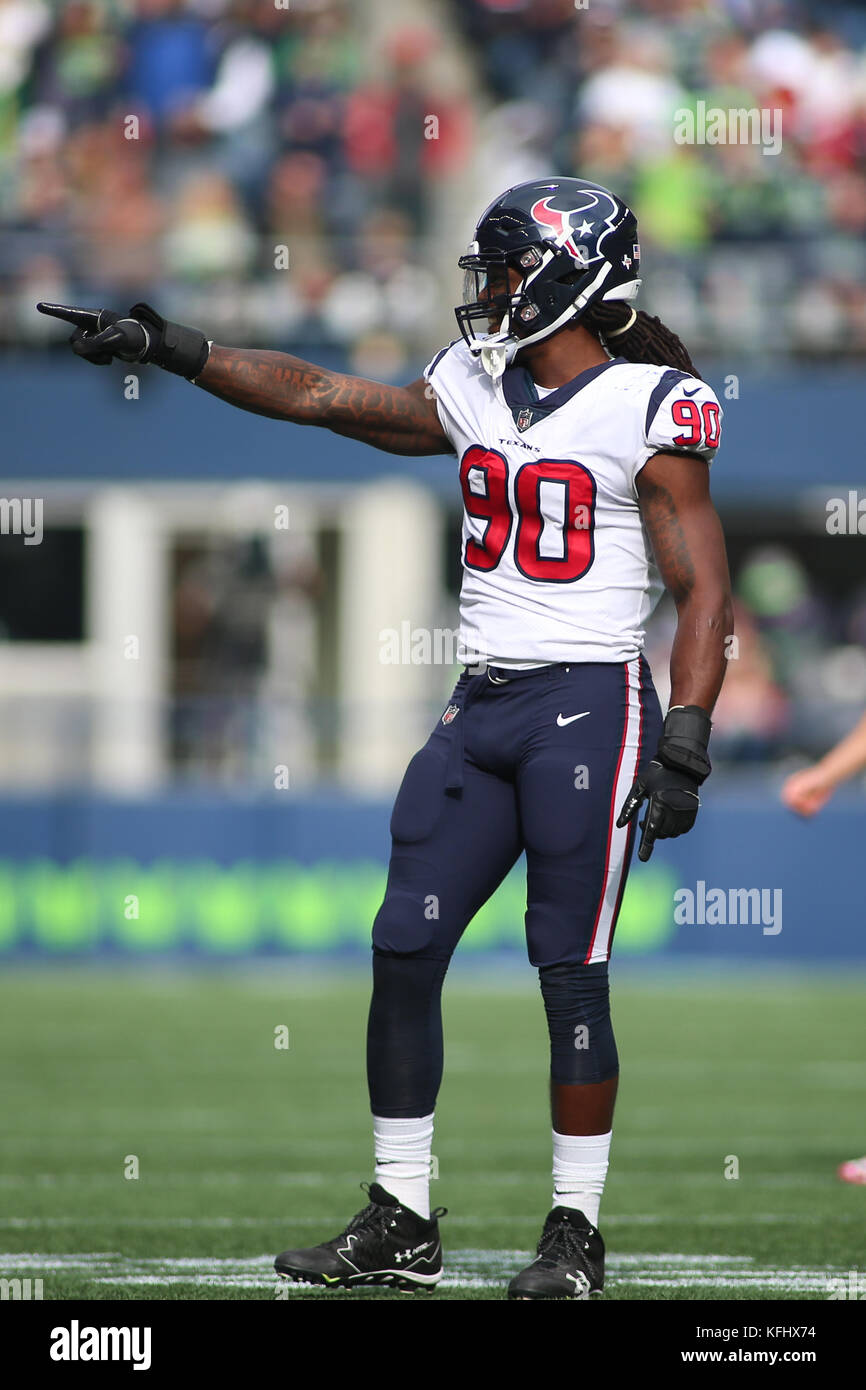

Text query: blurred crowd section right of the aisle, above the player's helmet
(453, 0), (866, 356)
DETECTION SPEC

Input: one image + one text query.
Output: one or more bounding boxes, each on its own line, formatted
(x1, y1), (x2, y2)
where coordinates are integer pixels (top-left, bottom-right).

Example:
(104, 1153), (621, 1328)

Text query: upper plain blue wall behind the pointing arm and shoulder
(6, 354), (866, 505)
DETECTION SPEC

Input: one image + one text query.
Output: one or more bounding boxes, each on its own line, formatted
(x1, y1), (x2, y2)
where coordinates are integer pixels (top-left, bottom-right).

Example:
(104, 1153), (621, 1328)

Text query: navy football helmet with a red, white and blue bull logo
(455, 178), (641, 379)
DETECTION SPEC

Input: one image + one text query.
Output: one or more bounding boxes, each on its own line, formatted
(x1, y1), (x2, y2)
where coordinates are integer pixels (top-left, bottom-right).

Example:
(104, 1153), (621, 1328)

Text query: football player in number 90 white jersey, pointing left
(40, 178), (733, 1300)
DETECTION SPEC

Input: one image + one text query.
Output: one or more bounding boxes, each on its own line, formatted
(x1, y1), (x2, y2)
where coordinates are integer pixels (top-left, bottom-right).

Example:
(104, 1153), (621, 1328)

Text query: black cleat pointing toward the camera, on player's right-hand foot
(509, 1207), (605, 1298)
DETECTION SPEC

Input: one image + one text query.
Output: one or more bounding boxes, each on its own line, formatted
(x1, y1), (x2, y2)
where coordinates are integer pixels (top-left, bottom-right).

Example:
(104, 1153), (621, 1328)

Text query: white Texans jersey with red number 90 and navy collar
(424, 341), (721, 664)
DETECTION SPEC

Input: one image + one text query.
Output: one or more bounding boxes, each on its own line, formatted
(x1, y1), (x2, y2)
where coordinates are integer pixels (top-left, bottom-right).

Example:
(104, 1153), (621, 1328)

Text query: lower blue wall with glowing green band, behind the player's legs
(0, 788), (866, 967)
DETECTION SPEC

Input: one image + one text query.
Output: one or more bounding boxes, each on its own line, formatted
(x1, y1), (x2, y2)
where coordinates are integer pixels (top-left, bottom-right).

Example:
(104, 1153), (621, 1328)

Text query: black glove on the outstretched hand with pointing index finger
(36, 302), (210, 381)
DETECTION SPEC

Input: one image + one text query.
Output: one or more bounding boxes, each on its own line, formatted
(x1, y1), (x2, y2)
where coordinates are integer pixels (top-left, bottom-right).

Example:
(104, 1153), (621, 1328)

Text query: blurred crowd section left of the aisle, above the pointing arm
(0, 0), (466, 371)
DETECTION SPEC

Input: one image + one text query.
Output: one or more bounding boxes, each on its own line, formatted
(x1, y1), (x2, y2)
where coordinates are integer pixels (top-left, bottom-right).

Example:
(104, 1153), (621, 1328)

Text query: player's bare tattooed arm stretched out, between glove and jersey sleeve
(196, 345), (453, 455)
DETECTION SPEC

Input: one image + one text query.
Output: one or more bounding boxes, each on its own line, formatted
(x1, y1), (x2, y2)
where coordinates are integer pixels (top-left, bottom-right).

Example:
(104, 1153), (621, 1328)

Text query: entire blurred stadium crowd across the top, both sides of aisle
(0, 0), (866, 374)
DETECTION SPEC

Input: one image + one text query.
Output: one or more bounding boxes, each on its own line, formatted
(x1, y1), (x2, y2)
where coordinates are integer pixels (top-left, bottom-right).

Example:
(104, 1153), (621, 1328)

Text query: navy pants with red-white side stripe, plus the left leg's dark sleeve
(367, 657), (662, 1116)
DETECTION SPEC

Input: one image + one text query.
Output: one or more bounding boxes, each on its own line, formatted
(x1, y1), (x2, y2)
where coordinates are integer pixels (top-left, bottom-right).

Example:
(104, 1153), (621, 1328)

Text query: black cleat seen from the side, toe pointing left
(274, 1183), (446, 1291)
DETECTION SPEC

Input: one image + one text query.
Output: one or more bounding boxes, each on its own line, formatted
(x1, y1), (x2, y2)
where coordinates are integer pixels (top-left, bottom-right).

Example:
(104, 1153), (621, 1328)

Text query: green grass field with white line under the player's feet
(0, 962), (866, 1300)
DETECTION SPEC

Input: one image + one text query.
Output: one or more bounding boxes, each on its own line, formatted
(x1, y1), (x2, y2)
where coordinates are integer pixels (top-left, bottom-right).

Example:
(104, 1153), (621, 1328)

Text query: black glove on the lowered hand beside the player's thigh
(617, 705), (713, 863)
